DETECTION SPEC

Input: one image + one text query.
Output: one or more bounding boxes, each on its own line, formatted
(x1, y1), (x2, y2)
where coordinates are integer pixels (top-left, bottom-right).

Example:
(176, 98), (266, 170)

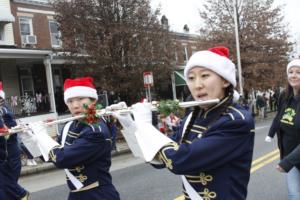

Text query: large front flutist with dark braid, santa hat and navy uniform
(112, 47), (254, 200)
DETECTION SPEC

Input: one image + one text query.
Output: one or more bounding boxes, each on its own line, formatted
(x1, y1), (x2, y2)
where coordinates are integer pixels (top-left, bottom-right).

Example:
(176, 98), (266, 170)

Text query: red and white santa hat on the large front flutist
(184, 46), (236, 87)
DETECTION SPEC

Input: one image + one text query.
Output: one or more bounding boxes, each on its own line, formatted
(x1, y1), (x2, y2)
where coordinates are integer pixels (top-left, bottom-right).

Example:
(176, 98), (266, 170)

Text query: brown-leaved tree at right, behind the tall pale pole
(200, 0), (292, 89)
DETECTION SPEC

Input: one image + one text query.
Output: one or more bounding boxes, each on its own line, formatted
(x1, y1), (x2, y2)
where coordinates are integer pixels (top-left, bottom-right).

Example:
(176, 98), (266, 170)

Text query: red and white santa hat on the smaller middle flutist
(64, 77), (98, 103)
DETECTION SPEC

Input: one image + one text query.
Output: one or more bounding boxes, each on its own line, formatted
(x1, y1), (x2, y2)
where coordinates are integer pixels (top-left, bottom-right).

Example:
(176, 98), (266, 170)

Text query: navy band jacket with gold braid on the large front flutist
(155, 98), (254, 200)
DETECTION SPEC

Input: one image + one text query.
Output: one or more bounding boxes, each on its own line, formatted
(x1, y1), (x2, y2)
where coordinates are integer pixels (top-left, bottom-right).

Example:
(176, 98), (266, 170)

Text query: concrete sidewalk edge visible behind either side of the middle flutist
(21, 141), (130, 176)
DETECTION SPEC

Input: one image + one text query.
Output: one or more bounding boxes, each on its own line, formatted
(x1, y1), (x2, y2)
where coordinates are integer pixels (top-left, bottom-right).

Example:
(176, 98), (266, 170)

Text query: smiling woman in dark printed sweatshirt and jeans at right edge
(265, 59), (300, 200)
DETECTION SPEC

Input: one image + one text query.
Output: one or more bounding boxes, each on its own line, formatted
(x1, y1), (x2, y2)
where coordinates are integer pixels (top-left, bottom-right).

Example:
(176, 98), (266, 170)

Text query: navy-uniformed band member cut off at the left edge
(0, 82), (29, 200)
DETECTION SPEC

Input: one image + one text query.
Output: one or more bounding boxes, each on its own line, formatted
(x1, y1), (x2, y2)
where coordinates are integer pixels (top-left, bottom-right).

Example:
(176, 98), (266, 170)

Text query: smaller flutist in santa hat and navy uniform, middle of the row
(25, 77), (120, 200)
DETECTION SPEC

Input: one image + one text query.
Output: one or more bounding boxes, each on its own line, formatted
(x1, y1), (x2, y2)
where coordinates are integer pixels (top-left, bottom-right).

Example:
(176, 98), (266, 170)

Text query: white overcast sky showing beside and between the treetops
(151, 0), (300, 54)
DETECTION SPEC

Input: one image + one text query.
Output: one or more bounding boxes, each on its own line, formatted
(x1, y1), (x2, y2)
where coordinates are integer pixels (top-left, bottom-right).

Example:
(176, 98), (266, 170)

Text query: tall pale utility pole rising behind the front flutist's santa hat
(233, 0), (244, 96)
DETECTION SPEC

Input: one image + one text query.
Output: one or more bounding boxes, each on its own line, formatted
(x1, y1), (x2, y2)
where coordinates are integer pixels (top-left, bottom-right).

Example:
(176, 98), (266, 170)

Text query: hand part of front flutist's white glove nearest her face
(132, 102), (152, 124)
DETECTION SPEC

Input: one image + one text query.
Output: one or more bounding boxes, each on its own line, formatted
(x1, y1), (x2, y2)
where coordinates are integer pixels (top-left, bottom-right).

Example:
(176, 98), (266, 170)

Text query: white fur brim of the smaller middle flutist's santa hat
(64, 86), (98, 103)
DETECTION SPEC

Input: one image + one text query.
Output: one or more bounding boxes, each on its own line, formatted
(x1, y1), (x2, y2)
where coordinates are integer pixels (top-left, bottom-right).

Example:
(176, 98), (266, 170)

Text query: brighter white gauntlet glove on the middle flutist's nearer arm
(28, 122), (59, 161)
